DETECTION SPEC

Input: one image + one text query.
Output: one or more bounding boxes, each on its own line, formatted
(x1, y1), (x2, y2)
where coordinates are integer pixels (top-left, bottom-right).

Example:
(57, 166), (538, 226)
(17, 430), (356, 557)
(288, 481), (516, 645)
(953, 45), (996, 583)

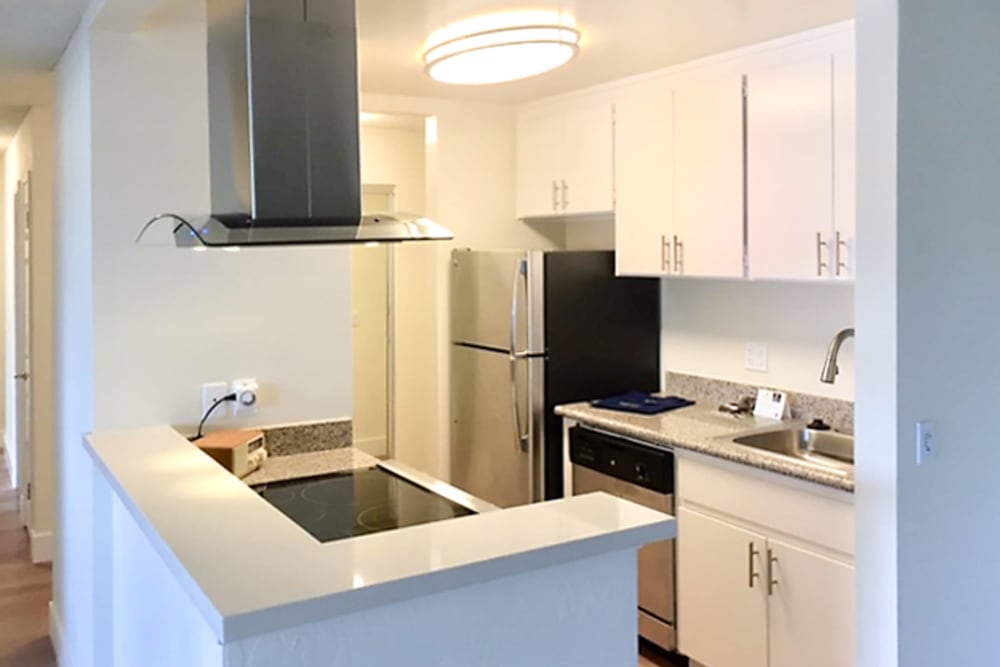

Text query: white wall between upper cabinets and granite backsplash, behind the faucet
(660, 279), (854, 400)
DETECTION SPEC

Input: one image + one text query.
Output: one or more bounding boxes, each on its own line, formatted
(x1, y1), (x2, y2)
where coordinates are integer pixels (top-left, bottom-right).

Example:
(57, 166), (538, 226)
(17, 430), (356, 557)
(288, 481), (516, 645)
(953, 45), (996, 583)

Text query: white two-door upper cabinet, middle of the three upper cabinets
(615, 70), (743, 277)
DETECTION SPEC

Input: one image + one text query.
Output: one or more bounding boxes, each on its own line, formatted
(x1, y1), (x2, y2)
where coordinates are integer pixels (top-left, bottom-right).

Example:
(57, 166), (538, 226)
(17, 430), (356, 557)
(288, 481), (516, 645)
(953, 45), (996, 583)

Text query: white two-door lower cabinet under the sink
(677, 459), (855, 667)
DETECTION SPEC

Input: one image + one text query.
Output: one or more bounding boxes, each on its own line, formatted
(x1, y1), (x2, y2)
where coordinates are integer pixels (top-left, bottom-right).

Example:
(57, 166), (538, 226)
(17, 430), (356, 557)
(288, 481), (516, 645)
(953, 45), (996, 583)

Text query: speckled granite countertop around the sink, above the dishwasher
(556, 403), (854, 493)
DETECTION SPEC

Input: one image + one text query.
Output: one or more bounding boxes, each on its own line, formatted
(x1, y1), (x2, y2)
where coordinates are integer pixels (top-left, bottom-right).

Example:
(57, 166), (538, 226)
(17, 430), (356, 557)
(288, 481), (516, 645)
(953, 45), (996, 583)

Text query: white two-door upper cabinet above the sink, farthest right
(747, 33), (855, 280)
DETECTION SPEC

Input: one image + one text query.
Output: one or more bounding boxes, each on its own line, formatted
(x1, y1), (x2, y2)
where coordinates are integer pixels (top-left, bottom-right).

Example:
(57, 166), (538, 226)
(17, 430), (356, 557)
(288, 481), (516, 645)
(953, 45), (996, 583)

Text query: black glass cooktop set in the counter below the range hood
(248, 467), (473, 542)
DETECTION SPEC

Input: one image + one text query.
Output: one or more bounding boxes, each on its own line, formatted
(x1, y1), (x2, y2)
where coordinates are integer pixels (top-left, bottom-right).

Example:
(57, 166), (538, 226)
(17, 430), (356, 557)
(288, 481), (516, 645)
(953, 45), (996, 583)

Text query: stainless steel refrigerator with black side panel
(450, 250), (660, 507)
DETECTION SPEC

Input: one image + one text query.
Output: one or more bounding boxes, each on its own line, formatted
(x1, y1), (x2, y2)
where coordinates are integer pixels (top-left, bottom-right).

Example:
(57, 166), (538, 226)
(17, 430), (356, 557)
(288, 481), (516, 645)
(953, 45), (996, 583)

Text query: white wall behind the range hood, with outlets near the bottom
(91, 21), (353, 430)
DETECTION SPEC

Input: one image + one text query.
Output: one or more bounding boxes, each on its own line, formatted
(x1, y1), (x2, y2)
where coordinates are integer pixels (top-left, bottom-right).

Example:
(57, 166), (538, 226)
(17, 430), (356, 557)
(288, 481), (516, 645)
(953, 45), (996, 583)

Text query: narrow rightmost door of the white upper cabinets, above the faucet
(833, 48), (857, 280)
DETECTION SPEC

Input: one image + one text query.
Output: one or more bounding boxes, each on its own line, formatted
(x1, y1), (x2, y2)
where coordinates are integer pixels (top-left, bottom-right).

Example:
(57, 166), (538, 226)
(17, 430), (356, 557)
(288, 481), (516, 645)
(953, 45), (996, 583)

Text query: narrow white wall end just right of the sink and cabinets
(854, 0), (900, 667)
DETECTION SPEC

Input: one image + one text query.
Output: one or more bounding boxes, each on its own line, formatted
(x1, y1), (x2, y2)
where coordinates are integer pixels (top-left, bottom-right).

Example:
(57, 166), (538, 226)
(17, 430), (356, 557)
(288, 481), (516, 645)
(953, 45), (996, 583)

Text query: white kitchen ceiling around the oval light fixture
(358, 0), (854, 102)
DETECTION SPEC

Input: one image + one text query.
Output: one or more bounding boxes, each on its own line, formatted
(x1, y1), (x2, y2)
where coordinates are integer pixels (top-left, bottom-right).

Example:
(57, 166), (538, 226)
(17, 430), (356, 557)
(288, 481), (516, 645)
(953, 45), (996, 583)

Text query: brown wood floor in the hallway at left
(0, 457), (56, 667)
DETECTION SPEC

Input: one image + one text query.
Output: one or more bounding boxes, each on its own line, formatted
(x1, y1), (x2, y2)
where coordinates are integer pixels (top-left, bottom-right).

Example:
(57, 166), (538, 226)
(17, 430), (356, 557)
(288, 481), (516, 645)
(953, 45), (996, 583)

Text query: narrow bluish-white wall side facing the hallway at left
(52, 15), (95, 667)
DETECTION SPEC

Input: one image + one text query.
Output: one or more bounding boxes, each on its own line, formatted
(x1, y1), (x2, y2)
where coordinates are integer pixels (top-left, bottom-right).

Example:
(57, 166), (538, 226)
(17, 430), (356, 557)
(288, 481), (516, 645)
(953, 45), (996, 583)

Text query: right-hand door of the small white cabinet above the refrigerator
(560, 101), (614, 215)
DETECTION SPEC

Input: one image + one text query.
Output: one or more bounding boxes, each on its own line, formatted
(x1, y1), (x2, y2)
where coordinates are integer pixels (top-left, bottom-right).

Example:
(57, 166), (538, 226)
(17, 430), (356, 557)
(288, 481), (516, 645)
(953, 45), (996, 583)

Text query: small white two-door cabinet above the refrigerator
(517, 98), (614, 218)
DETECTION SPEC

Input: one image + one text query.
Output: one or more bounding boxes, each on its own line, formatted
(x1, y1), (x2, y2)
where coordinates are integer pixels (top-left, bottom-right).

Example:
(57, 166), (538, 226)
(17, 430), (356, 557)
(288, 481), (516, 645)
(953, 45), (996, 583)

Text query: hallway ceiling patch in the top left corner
(0, 0), (91, 72)
